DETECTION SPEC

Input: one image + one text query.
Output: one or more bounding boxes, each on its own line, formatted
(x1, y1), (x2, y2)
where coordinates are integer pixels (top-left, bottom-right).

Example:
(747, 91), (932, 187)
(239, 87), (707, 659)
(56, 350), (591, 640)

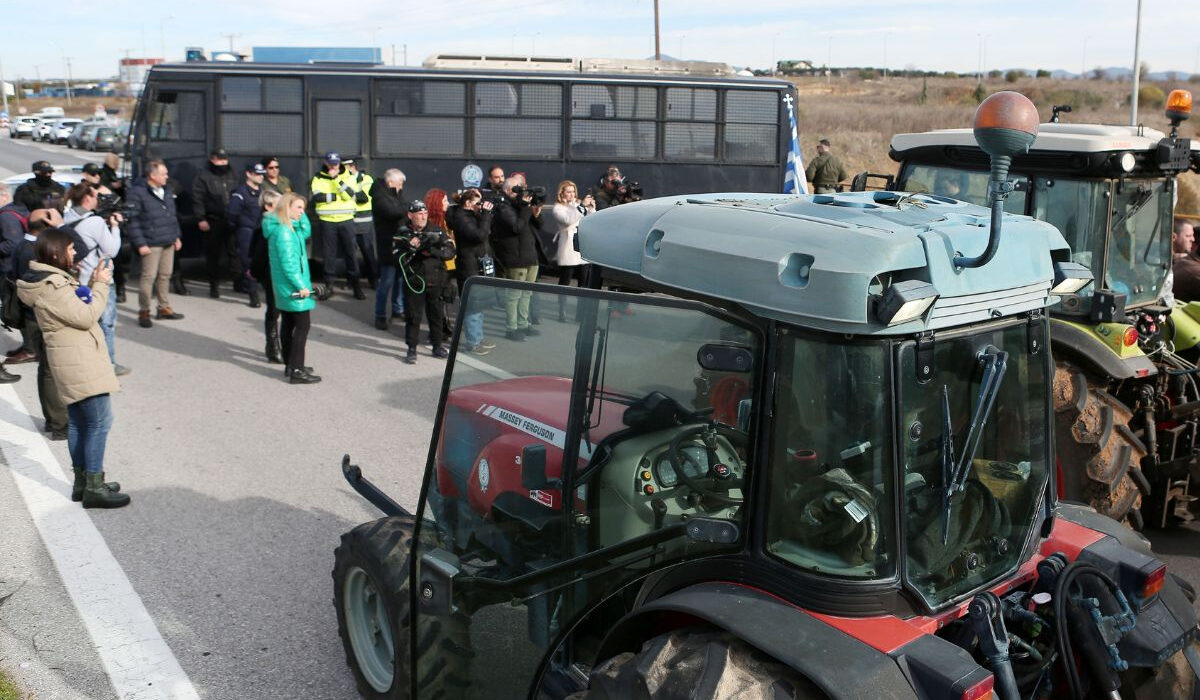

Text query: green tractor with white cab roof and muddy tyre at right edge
(873, 90), (1200, 530)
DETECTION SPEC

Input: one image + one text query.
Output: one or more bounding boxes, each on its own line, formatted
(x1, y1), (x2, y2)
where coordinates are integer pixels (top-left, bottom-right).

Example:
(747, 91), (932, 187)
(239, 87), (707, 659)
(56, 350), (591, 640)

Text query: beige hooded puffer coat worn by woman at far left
(17, 261), (121, 405)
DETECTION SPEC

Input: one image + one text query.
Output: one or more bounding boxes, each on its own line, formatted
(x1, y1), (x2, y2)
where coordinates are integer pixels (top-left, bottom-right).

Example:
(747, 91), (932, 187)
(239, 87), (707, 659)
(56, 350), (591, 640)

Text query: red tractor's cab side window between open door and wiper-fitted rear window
(767, 334), (895, 579)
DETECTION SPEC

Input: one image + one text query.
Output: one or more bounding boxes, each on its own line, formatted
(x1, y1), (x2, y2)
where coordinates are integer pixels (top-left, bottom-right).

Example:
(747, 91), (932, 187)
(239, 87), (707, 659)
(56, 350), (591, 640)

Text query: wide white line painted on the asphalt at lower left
(0, 384), (199, 700)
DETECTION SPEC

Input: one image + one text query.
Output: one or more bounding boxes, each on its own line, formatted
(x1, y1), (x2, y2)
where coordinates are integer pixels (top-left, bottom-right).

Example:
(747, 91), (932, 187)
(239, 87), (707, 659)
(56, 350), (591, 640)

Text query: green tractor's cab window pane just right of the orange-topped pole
(1033, 178), (1110, 298)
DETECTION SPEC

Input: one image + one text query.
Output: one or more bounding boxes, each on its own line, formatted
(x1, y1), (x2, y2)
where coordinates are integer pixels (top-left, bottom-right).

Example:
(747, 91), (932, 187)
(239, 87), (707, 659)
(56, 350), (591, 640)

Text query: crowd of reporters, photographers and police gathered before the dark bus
(0, 148), (641, 508)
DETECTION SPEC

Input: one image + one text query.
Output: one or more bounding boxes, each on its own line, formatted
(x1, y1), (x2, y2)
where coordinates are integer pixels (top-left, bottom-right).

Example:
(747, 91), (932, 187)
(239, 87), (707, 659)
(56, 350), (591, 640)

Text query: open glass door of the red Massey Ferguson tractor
(412, 277), (762, 698)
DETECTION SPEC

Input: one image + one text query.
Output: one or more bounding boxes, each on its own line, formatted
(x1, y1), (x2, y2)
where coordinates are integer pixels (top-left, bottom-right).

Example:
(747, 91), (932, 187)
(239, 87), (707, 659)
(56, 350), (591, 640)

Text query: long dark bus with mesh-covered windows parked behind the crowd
(130, 56), (794, 207)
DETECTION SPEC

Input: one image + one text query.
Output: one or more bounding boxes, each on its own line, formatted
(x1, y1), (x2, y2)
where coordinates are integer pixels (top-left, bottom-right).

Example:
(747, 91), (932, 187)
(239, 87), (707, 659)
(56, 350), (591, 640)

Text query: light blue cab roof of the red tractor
(580, 192), (1069, 335)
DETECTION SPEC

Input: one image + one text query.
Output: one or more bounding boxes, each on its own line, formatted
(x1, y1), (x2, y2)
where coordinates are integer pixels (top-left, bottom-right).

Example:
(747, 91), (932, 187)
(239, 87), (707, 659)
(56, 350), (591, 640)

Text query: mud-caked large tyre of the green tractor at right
(1054, 363), (1150, 530)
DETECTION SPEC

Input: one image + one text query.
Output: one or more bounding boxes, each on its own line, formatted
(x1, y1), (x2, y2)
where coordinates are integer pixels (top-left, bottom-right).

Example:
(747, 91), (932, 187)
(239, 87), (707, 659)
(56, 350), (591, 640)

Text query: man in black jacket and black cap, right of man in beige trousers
(192, 148), (237, 299)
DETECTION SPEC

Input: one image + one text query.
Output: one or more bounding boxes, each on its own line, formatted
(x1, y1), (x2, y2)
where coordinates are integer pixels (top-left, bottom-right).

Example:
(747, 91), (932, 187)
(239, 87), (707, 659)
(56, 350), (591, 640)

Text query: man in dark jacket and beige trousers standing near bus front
(128, 160), (184, 328)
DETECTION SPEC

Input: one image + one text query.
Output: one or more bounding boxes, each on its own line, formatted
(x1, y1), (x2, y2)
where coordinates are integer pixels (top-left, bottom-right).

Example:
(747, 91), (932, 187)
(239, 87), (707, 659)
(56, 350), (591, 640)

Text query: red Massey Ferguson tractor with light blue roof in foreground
(334, 92), (1200, 700)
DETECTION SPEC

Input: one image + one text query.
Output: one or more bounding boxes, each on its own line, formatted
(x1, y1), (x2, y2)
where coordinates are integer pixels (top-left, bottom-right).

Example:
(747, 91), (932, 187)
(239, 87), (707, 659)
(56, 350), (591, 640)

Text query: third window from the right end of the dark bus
(571, 84), (658, 160)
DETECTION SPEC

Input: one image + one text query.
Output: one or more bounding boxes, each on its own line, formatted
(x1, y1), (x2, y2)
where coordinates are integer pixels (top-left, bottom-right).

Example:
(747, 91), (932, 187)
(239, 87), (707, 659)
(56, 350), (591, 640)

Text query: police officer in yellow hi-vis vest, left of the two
(308, 151), (370, 299)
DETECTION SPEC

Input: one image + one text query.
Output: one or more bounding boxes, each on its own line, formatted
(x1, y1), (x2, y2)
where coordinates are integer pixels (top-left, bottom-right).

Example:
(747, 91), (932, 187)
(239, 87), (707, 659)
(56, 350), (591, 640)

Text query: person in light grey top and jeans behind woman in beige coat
(62, 183), (130, 377)
